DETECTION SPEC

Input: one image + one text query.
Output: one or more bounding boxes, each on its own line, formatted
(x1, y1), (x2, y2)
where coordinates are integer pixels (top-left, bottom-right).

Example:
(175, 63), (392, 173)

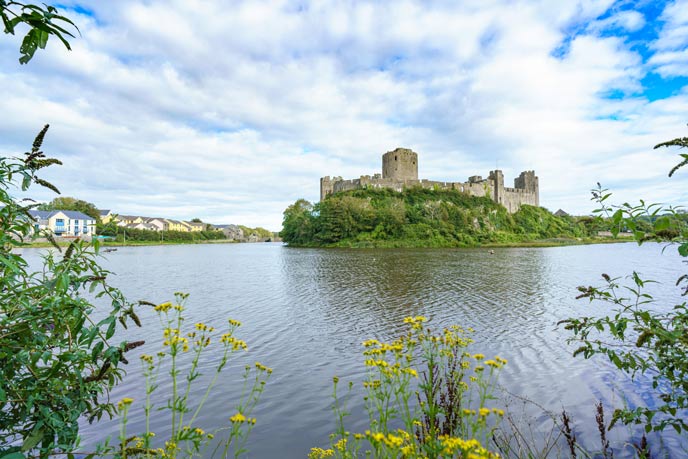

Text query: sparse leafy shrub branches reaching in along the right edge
(562, 128), (688, 433)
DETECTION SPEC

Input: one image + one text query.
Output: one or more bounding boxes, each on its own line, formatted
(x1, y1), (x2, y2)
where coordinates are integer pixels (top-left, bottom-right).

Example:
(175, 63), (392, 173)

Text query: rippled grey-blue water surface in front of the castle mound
(21, 244), (681, 458)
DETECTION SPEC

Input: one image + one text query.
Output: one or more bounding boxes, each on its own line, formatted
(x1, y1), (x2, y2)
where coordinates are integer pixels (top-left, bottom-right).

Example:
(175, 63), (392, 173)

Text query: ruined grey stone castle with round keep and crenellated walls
(320, 148), (540, 213)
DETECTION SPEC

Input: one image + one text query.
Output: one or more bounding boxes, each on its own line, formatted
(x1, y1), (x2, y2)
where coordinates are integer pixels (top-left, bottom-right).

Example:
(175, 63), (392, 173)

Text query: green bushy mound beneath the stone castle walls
(282, 188), (592, 247)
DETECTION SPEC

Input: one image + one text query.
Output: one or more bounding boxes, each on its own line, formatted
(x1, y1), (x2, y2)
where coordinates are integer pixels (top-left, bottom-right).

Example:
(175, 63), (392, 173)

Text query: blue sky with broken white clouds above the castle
(0, 0), (688, 231)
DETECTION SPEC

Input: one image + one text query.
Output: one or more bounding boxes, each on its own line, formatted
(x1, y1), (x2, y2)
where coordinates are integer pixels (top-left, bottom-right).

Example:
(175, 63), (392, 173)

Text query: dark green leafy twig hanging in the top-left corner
(0, 0), (79, 64)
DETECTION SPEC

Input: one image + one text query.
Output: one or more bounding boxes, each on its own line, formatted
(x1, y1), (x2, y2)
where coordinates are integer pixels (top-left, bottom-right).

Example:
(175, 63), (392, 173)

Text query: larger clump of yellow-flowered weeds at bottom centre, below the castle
(309, 316), (506, 459)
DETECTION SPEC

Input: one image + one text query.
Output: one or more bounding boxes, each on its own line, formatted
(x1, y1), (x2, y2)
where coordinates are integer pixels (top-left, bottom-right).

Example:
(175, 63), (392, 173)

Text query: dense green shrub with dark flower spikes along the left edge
(0, 126), (141, 457)
